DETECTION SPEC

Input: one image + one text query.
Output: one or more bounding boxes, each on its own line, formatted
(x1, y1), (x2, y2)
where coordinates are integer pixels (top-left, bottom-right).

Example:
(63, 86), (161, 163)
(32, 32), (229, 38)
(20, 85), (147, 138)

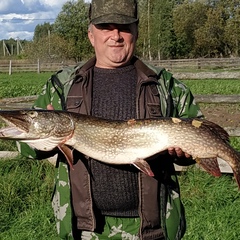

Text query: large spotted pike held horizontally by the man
(0, 110), (240, 188)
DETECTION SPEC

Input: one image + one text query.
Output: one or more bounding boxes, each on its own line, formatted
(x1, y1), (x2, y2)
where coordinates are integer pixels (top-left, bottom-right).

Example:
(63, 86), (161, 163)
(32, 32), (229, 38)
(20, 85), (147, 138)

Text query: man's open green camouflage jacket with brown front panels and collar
(20, 58), (202, 240)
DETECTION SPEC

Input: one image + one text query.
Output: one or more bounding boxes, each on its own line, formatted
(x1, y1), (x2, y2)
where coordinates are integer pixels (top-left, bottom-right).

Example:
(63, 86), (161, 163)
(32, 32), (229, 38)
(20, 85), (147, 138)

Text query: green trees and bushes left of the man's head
(25, 0), (93, 62)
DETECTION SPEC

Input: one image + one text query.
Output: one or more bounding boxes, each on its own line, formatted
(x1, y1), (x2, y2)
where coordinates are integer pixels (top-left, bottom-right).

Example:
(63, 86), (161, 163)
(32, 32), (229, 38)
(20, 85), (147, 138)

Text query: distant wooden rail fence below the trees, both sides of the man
(0, 58), (240, 74)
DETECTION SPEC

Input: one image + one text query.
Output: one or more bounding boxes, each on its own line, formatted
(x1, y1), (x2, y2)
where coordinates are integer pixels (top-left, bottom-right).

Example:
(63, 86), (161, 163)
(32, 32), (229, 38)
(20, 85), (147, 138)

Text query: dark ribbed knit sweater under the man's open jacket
(90, 65), (138, 217)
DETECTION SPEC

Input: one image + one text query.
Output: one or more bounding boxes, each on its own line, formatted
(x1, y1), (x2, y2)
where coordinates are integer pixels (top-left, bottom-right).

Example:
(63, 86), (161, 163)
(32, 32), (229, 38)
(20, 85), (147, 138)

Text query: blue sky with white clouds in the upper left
(0, 0), (90, 40)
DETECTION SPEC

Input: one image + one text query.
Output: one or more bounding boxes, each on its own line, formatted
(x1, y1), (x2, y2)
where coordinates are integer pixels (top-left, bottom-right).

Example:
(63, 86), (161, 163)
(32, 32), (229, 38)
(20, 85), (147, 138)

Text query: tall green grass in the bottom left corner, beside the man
(0, 157), (57, 240)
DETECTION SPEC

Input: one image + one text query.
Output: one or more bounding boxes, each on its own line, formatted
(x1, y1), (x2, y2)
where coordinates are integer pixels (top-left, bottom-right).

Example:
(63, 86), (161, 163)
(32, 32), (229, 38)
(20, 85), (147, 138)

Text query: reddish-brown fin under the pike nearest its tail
(195, 157), (222, 177)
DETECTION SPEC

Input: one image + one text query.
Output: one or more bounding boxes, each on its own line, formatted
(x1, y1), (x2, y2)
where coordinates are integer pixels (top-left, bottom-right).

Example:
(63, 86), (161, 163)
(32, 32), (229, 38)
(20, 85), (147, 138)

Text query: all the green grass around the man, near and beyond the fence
(0, 73), (240, 240)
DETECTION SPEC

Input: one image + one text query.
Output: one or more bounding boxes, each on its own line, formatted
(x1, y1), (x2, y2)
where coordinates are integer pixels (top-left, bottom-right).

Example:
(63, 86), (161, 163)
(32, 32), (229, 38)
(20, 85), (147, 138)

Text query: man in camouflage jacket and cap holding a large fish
(21, 0), (202, 240)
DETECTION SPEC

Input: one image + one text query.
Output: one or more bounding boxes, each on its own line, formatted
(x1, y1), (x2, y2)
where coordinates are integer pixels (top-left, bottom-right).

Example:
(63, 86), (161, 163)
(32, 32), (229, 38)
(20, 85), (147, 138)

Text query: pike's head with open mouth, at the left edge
(0, 110), (74, 150)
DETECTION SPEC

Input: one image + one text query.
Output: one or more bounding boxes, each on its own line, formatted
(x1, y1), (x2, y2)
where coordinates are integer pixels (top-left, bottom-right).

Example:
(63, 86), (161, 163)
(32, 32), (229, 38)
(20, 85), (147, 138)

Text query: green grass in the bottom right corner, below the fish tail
(179, 168), (240, 240)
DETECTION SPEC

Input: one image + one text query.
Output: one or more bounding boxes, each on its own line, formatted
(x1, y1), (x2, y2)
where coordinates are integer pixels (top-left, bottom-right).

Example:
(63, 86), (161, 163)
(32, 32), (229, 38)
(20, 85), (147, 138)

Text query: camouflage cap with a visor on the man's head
(89, 0), (138, 25)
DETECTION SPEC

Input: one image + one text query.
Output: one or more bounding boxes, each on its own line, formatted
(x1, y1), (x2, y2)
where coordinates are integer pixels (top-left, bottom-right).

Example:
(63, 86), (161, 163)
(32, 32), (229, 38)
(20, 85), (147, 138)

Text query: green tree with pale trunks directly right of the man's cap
(137, 0), (179, 60)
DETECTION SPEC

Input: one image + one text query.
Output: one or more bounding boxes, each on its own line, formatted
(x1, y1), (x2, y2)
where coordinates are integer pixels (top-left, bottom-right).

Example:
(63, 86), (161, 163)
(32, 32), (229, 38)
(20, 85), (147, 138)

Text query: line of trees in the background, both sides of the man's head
(1, 0), (240, 62)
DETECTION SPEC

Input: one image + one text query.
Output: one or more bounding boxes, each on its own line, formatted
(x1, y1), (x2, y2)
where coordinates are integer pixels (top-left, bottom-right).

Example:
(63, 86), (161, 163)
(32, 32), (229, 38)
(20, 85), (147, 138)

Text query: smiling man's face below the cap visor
(88, 23), (138, 68)
